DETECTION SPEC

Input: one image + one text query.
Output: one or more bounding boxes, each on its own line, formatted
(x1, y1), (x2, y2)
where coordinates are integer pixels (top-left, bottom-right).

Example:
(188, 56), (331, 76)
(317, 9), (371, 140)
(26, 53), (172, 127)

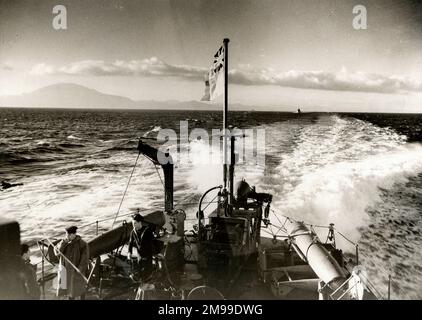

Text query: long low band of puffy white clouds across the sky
(30, 57), (422, 93)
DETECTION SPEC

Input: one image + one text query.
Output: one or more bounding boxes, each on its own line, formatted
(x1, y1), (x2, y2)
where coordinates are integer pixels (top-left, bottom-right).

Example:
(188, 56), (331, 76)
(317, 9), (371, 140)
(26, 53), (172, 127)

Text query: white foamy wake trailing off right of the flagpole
(270, 116), (422, 234)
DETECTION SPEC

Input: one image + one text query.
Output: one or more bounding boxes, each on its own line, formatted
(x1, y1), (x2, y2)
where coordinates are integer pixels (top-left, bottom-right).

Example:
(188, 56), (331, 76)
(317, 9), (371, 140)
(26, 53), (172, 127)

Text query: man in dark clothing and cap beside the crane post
(128, 213), (154, 279)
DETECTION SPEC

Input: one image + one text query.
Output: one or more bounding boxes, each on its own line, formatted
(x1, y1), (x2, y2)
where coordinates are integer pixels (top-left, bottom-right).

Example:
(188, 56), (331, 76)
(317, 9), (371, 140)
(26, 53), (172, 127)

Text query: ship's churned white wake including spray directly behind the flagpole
(184, 116), (422, 241)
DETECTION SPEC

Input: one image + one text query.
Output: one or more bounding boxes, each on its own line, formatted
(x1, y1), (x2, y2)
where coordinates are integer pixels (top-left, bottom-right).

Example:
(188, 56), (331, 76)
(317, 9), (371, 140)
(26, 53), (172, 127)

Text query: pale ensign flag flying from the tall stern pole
(201, 46), (224, 101)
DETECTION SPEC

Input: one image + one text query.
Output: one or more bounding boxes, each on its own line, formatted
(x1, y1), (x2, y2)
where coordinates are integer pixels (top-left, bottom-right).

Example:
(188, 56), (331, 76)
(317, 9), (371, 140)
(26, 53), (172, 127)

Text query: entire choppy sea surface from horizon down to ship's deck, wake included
(0, 108), (422, 299)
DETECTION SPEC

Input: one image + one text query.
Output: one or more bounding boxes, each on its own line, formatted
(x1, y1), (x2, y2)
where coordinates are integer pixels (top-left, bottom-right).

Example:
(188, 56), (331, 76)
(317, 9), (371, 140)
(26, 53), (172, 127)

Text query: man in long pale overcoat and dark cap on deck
(58, 226), (89, 300)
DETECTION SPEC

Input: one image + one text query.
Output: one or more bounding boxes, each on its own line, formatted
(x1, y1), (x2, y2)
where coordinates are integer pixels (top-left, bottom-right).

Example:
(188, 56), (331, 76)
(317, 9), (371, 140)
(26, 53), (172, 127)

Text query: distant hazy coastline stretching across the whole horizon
(0, 83), (421, 114)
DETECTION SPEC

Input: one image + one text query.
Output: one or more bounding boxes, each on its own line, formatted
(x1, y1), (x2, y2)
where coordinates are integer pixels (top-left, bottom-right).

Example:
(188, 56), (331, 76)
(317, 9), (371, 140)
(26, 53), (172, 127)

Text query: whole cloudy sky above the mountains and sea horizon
(0, 0), (422, 112)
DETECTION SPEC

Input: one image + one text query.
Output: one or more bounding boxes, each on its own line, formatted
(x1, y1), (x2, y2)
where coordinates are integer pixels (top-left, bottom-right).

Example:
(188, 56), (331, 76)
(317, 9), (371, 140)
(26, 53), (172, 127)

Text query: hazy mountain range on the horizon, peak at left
(0, 83), (251, 110)
